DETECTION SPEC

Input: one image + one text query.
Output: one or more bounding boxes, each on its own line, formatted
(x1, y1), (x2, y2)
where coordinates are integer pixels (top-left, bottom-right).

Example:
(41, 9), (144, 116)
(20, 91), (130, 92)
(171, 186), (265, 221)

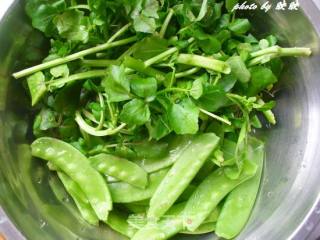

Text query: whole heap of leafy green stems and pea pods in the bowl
(13, 0), (311, 240)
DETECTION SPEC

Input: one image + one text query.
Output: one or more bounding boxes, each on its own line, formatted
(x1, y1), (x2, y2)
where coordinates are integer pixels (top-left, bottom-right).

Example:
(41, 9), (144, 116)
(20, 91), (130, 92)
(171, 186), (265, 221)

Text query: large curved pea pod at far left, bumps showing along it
(31, 137), (112, 221)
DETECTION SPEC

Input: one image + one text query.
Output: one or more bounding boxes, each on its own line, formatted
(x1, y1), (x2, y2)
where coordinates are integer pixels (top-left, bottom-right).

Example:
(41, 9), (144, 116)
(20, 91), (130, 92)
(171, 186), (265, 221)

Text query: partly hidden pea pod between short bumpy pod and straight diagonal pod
(135, 136), (192, 173)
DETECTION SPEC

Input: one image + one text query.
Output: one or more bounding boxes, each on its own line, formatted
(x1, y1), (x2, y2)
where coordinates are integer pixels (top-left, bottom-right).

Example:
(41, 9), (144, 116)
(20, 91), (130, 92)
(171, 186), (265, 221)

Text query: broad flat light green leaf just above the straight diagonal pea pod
(169, 98), (199, 134)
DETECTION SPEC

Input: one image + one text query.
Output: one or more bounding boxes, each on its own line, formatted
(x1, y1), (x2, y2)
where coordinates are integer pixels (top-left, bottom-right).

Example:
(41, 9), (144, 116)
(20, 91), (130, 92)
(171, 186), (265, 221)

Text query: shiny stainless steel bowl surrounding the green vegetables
(0, 0), (320, 240)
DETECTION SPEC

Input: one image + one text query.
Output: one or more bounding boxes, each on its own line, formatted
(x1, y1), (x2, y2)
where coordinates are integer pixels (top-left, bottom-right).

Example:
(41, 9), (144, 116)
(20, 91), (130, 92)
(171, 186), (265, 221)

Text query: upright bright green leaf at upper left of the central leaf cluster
(103, 65), (131, 102)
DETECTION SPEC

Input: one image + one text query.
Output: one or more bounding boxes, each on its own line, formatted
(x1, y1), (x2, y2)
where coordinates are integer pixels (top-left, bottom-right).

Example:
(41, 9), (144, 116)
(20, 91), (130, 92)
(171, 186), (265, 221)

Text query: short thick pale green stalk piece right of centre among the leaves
(177, 54), (231, 74)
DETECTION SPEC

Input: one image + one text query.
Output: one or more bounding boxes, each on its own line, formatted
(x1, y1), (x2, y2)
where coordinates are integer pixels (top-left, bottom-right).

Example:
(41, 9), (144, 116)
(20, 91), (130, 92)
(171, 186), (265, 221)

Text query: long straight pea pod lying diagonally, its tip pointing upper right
(148, 133), (219, 219)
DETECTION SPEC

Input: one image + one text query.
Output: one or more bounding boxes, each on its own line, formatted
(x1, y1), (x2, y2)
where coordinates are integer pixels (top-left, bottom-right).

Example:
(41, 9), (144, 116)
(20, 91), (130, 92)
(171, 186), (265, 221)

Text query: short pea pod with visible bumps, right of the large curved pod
(89, 153), (148, 188)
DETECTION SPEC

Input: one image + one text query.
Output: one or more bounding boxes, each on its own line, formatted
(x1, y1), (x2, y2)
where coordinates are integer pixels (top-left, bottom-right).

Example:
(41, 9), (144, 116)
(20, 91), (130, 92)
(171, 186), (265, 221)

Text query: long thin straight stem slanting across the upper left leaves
(13, 36), (138, 79)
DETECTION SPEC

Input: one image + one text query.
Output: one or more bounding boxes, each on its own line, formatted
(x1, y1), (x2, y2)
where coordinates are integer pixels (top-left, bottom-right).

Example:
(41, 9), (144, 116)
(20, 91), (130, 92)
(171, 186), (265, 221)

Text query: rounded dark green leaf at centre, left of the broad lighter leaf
(120, 99), (150, 126)
